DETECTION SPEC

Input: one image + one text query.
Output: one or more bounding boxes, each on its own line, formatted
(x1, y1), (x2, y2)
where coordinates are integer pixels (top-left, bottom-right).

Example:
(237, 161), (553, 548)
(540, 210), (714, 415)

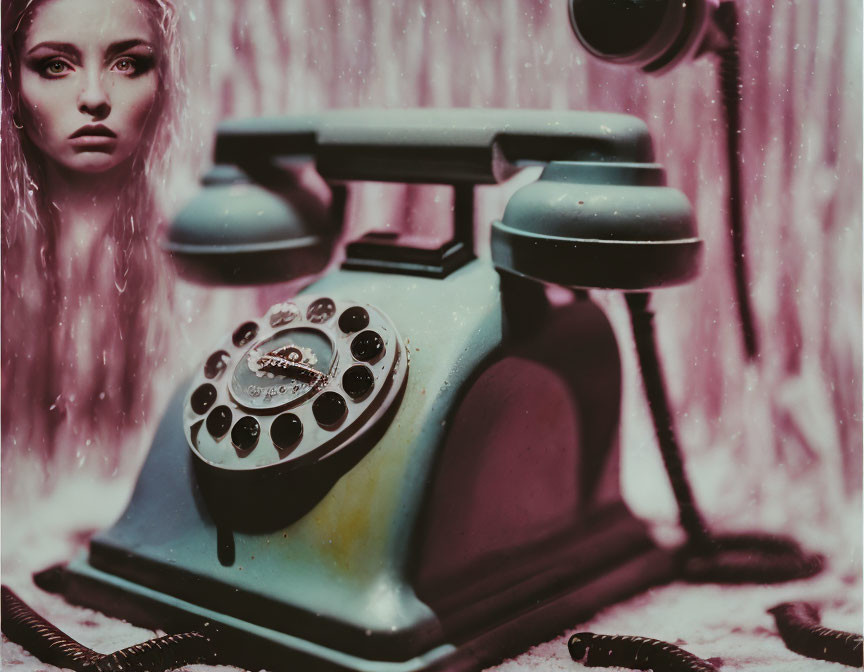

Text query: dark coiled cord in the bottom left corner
(0, 586), (217, 672)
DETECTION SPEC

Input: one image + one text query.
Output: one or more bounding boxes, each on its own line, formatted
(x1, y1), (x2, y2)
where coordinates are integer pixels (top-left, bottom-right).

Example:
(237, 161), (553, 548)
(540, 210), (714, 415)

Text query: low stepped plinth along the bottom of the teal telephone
(45, 547), (677, 672)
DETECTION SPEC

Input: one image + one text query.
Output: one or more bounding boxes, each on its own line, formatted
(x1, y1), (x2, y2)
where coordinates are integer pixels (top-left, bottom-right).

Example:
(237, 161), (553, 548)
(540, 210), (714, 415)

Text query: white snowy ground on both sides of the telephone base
(0, 468), (862, 672)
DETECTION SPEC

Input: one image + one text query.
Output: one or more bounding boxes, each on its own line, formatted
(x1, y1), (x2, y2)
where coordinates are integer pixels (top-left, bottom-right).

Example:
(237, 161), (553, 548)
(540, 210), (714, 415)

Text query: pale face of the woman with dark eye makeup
(19, 0), (158, 173)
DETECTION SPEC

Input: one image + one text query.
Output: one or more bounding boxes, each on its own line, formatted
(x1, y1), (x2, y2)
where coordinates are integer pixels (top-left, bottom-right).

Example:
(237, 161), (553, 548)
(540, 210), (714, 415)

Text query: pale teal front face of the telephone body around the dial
(86, 262), (502, 660)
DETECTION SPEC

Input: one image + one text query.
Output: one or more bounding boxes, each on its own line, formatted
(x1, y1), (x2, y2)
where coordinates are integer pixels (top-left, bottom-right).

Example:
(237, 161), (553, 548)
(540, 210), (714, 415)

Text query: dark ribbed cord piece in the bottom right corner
(768, 602), (864, 667)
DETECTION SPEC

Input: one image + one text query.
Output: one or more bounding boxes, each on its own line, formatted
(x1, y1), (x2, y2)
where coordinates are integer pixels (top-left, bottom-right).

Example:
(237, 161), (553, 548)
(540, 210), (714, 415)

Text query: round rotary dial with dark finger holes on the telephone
(184, 297), (407, 470)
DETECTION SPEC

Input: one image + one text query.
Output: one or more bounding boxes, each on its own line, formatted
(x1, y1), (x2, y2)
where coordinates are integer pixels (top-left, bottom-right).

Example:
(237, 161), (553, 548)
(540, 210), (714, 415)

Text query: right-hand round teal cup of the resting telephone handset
(491, 161), (702, 291)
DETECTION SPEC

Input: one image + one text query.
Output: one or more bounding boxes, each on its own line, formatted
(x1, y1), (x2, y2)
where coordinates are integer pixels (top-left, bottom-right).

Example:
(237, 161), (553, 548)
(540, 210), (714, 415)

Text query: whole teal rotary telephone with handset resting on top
(44, 110), (701, 672)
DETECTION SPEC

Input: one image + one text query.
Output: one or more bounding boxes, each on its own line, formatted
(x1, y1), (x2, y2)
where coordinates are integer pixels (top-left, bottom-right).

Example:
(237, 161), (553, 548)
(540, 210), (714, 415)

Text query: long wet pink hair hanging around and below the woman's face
(0, 0), (185, 467)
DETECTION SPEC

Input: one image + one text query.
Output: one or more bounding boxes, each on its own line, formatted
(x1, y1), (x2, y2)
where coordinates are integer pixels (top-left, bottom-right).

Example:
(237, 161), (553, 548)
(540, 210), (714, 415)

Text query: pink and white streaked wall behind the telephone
(7, 0), (862, 540)
